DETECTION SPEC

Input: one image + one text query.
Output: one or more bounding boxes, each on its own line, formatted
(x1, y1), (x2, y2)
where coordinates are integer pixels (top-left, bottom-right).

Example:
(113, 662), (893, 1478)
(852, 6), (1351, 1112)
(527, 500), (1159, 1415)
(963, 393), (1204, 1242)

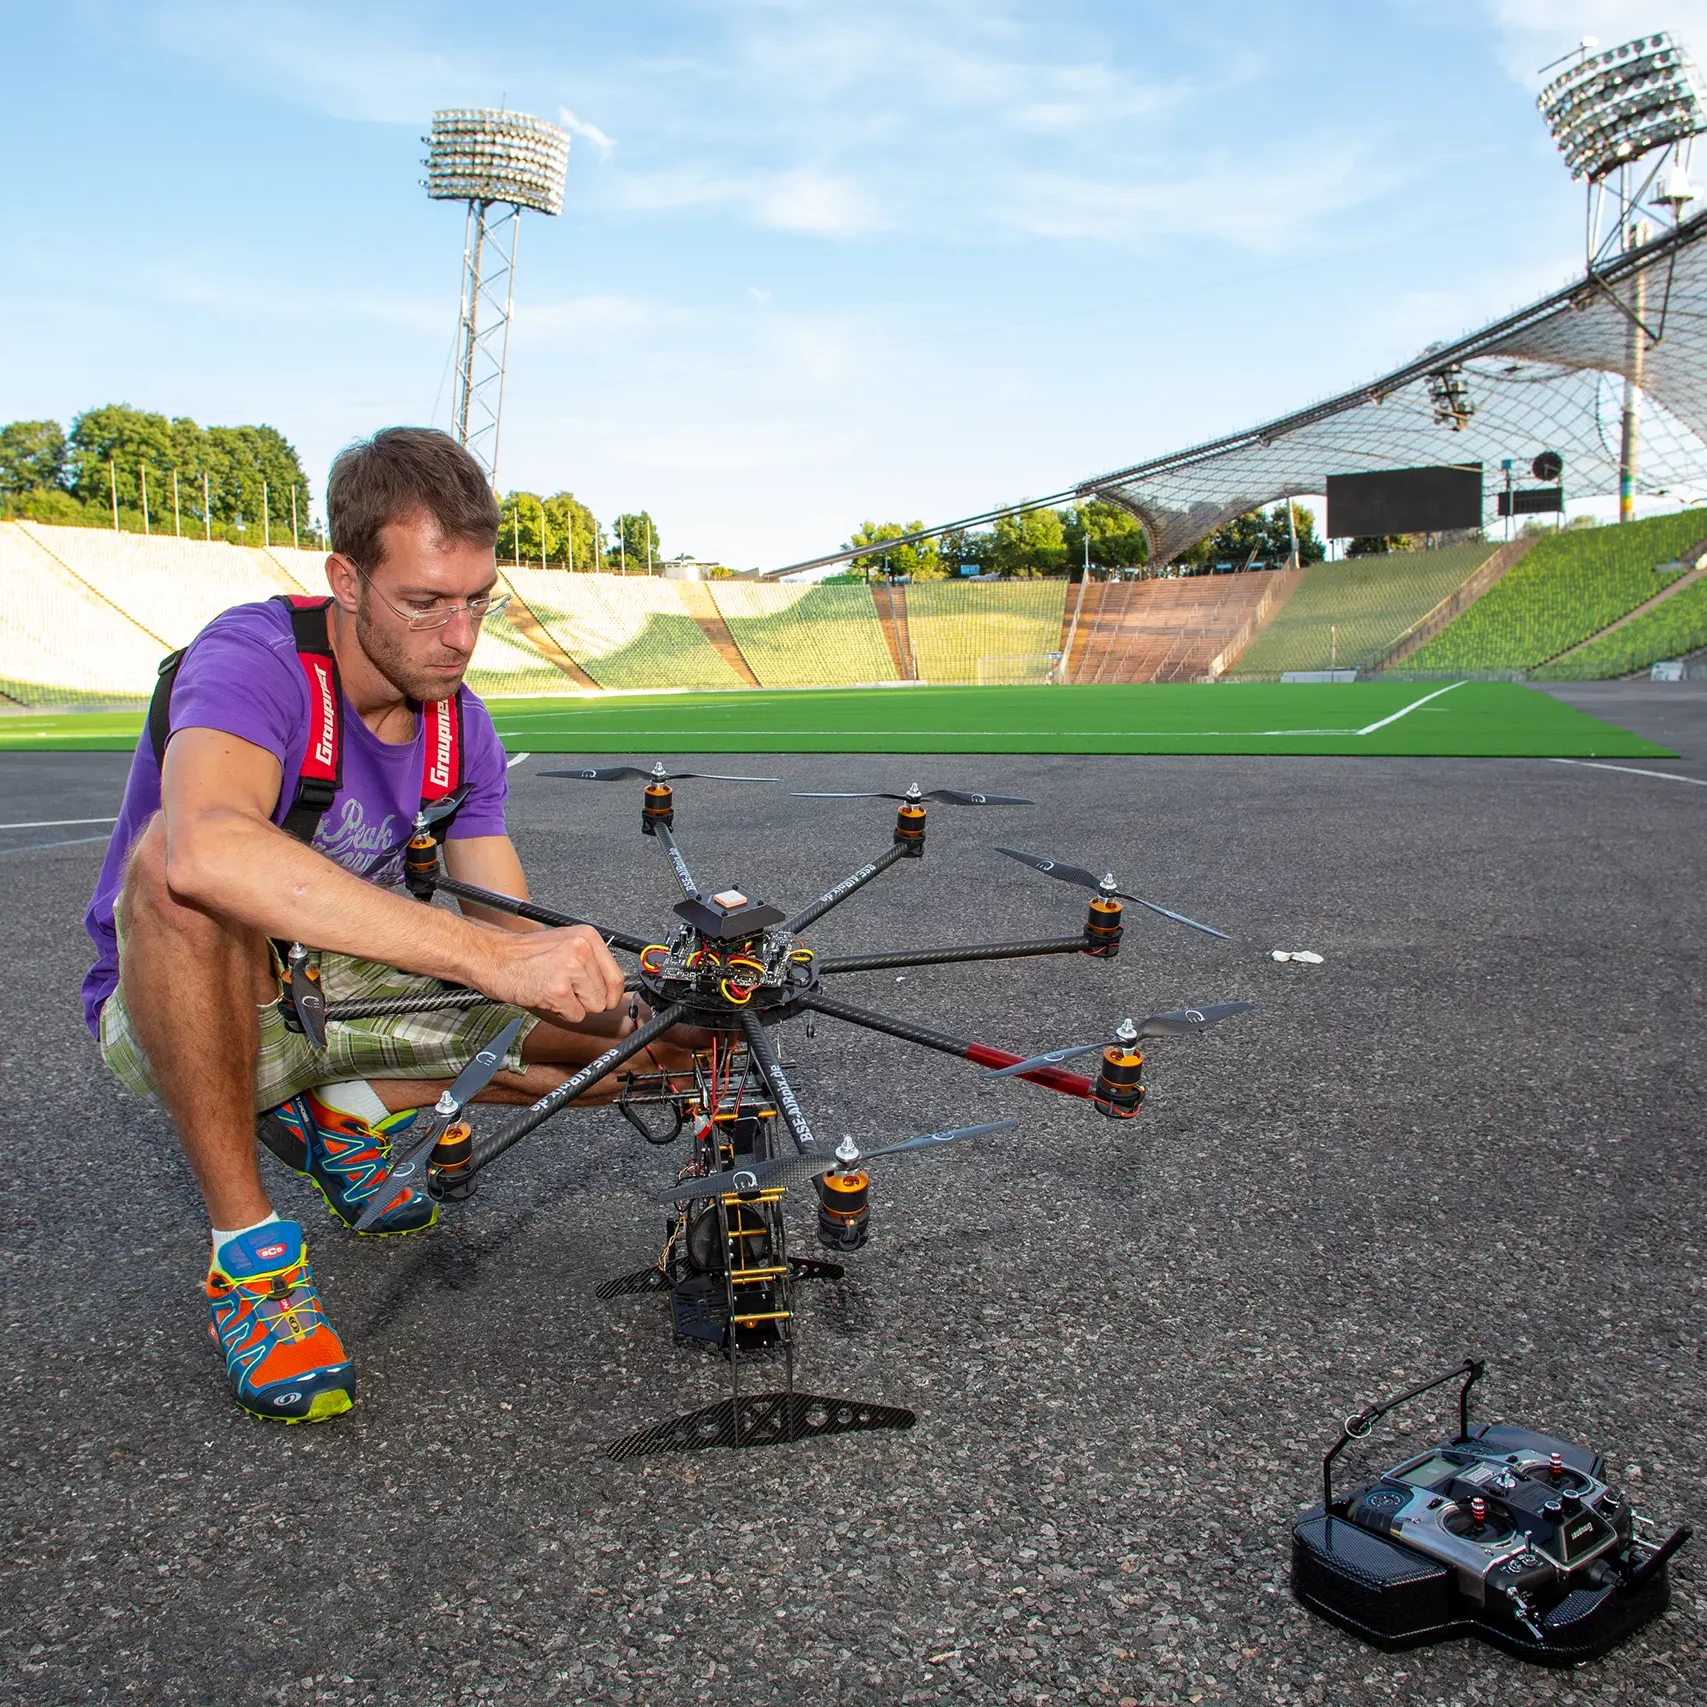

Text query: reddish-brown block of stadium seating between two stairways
(1070, 570), (1297, 683)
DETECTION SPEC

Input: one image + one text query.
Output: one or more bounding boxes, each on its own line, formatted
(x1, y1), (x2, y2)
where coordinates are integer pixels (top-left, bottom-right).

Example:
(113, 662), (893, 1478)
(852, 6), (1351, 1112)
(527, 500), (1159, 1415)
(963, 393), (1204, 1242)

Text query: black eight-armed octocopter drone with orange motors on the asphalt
(287, 765), (1251, 1458)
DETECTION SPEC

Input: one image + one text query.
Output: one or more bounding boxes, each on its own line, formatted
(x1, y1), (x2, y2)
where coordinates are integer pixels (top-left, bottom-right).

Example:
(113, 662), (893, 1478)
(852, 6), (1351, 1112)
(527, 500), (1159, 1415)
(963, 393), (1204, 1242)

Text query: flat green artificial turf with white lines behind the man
(0, 681), (1676, 758)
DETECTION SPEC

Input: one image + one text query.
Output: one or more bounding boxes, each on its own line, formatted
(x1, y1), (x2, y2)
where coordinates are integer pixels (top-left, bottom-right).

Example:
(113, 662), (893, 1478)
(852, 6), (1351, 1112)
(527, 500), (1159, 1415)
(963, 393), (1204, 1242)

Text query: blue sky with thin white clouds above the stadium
(0, 0), (1707, 567)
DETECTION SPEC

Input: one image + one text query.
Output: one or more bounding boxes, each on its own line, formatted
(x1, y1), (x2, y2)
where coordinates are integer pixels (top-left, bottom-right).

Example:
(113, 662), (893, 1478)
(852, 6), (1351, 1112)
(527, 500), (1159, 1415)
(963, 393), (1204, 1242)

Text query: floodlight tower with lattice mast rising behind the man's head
(422, 108), (568, 488)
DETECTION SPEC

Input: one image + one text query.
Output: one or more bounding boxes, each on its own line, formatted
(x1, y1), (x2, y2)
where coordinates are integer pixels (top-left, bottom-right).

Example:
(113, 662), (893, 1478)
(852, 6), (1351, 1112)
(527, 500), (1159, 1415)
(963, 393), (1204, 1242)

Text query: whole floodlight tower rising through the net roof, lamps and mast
(1536, 31), (1707, 522)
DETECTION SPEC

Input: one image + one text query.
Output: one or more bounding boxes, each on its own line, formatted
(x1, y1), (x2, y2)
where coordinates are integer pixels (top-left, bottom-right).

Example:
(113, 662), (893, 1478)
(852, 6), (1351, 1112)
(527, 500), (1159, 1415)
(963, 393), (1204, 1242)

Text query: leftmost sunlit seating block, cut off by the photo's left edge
(0, 522), (171, 708)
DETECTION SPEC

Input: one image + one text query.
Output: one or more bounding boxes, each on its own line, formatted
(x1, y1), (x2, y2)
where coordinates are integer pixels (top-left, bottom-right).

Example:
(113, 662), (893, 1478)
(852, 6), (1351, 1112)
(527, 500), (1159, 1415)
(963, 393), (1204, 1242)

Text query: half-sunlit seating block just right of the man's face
(504, 568), (741, 688)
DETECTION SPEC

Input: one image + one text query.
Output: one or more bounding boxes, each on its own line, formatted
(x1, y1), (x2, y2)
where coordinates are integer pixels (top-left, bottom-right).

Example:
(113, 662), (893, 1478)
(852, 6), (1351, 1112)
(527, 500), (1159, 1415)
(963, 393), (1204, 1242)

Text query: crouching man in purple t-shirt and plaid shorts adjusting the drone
(84, 427), (681, 1422)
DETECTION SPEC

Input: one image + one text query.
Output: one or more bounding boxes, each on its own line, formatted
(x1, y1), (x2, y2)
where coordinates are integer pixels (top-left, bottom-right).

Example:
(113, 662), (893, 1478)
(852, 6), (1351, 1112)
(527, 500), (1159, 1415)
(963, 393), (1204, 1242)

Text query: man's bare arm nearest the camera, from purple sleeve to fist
(160, 729), (623, 1024)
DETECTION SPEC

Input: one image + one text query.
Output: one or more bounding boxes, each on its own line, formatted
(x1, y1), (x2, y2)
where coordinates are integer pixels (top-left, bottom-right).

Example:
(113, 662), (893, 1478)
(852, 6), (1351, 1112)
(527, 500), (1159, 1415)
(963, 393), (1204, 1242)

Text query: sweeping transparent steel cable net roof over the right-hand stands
(1077, 203), (1707, 563)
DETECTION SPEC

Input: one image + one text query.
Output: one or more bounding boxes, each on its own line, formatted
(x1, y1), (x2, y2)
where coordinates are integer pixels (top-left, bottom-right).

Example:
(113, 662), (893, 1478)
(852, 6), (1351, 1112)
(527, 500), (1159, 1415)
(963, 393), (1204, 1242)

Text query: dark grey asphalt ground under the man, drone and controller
(0, 685), (1707, 1707)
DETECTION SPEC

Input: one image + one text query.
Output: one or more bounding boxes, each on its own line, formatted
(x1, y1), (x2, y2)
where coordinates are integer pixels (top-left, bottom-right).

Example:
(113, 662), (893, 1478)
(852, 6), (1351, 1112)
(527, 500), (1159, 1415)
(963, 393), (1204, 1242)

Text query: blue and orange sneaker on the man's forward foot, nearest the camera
(207, 1221), (355, 1422)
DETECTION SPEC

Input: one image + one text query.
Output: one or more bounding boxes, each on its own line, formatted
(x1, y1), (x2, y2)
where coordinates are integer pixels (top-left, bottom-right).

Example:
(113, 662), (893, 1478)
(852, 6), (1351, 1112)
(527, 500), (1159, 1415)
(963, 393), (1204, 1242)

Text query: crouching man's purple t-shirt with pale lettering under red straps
(84, 599), (509, 1036)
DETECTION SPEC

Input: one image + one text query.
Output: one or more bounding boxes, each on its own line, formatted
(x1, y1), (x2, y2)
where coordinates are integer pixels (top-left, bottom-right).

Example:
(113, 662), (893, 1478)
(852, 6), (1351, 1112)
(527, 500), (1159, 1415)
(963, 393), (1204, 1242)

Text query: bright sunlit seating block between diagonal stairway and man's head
(15, 522), (302, 652)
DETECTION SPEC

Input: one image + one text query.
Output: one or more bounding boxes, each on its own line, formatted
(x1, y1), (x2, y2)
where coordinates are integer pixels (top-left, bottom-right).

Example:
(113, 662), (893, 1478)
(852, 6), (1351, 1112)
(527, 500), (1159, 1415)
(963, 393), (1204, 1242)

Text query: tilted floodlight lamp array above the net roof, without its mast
(1536, 31), (1707, 183)
